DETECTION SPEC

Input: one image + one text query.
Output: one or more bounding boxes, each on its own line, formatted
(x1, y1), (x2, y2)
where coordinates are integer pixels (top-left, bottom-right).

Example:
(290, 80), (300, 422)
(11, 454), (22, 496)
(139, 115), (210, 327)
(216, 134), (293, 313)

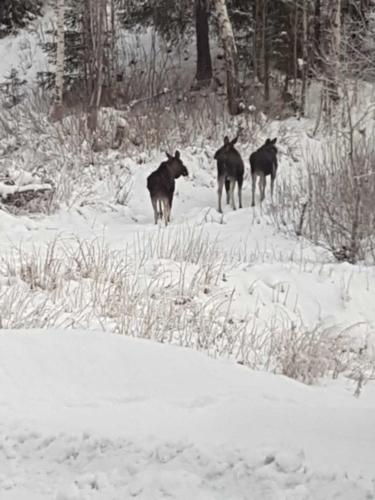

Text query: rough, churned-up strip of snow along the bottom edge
(0, 424), (375, 500)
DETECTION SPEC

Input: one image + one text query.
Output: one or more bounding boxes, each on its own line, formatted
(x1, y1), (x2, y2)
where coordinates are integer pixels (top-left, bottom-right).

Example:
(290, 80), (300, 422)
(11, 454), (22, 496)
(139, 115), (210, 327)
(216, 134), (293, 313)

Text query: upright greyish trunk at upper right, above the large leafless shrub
(321, 0), (341, 106)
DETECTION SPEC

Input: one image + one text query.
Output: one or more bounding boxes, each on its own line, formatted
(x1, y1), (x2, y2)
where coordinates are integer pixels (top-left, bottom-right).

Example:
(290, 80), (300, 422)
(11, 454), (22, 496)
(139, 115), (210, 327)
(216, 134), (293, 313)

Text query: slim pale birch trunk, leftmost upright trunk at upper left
(52, 0), (65, 120)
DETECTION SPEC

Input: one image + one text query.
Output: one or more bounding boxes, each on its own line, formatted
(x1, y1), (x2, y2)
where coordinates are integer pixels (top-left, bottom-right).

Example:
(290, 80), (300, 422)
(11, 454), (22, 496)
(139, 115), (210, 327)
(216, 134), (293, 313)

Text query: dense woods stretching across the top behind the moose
(0, 0), (374, 118)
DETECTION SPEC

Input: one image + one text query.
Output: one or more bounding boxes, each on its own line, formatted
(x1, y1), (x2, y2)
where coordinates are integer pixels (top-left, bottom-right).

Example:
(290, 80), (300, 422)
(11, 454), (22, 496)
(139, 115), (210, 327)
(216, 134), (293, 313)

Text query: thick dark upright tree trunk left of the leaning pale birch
(195, 0), (212, 86)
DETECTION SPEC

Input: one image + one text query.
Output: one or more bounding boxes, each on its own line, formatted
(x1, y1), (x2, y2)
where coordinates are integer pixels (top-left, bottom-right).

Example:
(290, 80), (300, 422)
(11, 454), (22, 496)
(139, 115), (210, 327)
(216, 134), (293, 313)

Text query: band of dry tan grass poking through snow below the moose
(0, 228), (374, 391)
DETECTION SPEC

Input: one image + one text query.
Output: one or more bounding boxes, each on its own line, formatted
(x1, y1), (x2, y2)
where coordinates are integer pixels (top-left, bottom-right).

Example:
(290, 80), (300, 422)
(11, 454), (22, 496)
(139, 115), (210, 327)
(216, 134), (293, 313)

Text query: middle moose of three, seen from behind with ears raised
(214, 134), (245, 213)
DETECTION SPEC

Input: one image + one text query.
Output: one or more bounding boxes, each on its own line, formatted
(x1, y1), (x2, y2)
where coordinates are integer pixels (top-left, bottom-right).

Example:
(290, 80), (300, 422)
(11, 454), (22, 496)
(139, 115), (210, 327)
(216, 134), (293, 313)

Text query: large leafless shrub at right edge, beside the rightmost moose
(274, 133), (375, 263)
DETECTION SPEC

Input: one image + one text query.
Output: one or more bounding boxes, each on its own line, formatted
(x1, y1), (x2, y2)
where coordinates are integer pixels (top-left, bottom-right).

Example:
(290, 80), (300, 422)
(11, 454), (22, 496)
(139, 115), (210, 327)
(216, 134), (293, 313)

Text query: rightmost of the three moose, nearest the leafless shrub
(250, 137), (277, 207)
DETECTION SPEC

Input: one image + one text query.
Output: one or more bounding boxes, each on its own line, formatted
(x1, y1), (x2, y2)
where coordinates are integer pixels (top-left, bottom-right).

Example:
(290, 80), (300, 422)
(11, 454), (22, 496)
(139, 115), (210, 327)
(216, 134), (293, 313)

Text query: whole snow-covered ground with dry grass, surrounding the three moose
(0, 8), (375, 500)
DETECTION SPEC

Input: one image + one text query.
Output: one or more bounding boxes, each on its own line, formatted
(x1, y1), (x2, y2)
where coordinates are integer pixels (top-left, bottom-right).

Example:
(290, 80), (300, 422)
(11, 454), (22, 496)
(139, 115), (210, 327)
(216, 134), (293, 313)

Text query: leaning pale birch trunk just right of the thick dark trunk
(213, 0), (240, 115)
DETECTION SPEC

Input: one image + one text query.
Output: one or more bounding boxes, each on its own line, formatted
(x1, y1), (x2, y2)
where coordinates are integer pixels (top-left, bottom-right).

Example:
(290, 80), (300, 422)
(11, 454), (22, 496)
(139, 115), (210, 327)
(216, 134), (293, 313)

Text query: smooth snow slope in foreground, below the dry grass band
(0, 331), (375, 500)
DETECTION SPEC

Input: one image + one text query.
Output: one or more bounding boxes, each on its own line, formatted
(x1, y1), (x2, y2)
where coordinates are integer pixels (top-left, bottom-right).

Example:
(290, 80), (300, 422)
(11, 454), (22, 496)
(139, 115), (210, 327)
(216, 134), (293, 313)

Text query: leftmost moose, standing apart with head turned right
(147, 151), (189, 226)
